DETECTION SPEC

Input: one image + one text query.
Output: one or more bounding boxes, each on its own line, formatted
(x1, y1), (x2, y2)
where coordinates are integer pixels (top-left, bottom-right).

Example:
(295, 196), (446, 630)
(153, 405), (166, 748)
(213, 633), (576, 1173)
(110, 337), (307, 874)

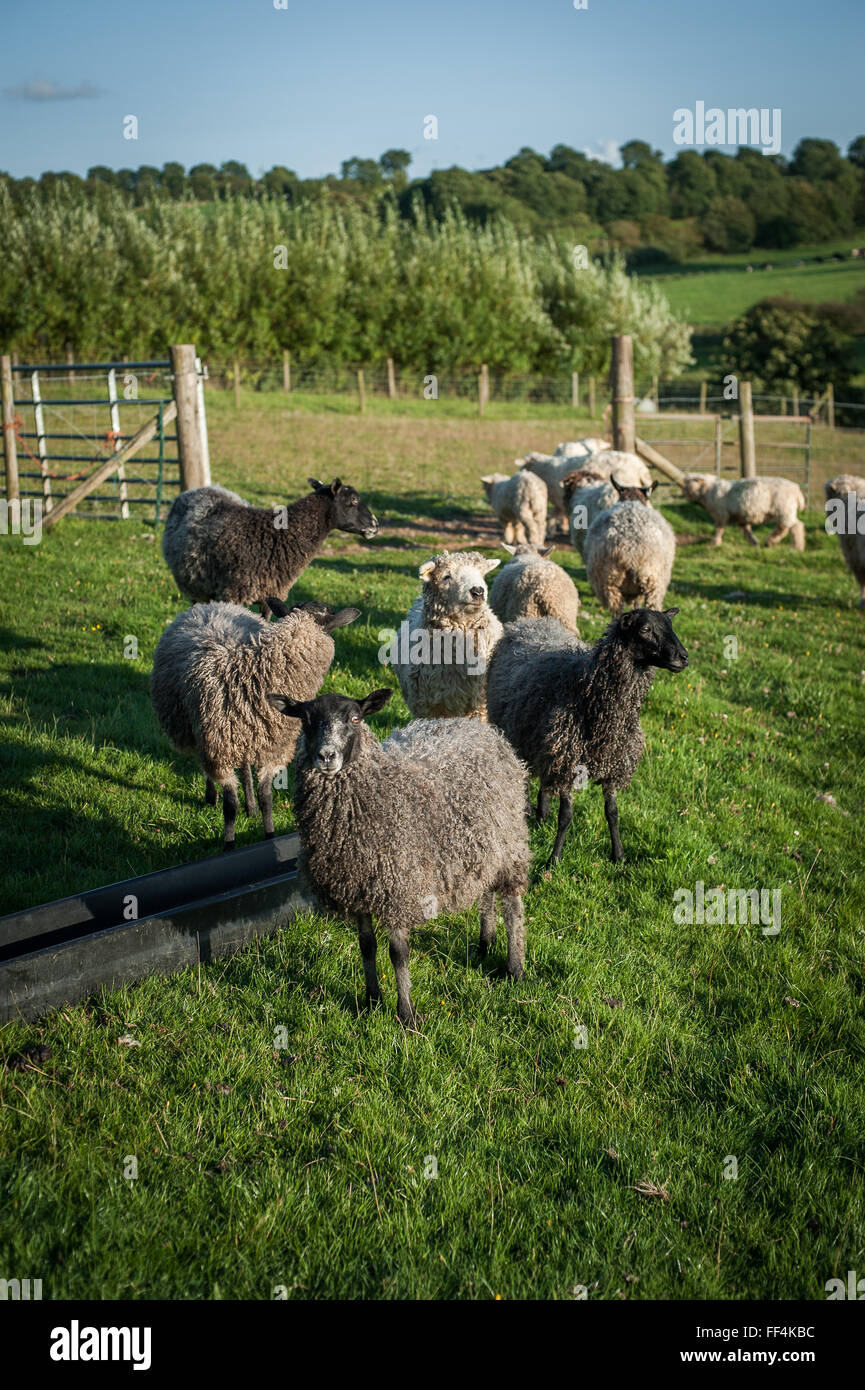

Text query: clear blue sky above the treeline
(0, 0), (865, 178)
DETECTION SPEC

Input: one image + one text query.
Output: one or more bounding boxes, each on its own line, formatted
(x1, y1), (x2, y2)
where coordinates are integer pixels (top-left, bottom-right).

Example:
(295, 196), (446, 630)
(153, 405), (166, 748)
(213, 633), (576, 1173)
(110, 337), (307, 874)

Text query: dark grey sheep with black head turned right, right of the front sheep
(487, 606), (688, 865)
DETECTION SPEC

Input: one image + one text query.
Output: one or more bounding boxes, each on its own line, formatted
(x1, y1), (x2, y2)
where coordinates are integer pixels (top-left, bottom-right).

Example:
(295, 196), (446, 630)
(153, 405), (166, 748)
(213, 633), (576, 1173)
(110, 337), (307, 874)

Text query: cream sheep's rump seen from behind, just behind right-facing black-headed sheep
(583, 496), (676, 617)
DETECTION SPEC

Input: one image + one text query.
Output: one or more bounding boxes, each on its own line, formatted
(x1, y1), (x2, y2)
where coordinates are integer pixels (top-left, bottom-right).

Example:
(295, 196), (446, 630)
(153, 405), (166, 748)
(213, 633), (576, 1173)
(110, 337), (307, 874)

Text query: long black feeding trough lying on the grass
(0, 834), (312, 1023)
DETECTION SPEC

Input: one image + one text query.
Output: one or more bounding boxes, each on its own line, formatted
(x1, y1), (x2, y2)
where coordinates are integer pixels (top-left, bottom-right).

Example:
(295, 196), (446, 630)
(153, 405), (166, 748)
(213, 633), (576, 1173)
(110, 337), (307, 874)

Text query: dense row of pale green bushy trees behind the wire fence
(0, 185), (690, 378)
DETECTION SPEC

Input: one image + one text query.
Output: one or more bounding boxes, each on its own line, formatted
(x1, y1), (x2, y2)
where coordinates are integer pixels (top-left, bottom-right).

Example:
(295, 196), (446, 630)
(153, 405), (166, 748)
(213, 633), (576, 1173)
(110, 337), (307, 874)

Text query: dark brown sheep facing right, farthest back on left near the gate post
(163, 478), (378, 617)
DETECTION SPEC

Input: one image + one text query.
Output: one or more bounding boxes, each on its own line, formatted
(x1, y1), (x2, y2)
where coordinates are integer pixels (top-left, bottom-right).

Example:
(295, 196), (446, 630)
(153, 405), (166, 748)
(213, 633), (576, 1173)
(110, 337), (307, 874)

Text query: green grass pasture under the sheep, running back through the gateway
(0, 395), (865, 1300)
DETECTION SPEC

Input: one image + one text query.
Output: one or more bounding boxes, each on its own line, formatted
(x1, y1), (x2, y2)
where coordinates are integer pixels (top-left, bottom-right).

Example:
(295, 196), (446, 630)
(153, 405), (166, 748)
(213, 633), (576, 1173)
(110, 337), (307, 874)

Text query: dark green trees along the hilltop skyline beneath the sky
(0, 136), (865, 255)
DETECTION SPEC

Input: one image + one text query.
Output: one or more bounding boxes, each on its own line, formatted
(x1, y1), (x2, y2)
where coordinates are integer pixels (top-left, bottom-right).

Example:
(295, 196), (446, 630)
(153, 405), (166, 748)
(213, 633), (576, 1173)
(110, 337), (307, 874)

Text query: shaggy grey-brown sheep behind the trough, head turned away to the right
(150, 596), (360, 849)
